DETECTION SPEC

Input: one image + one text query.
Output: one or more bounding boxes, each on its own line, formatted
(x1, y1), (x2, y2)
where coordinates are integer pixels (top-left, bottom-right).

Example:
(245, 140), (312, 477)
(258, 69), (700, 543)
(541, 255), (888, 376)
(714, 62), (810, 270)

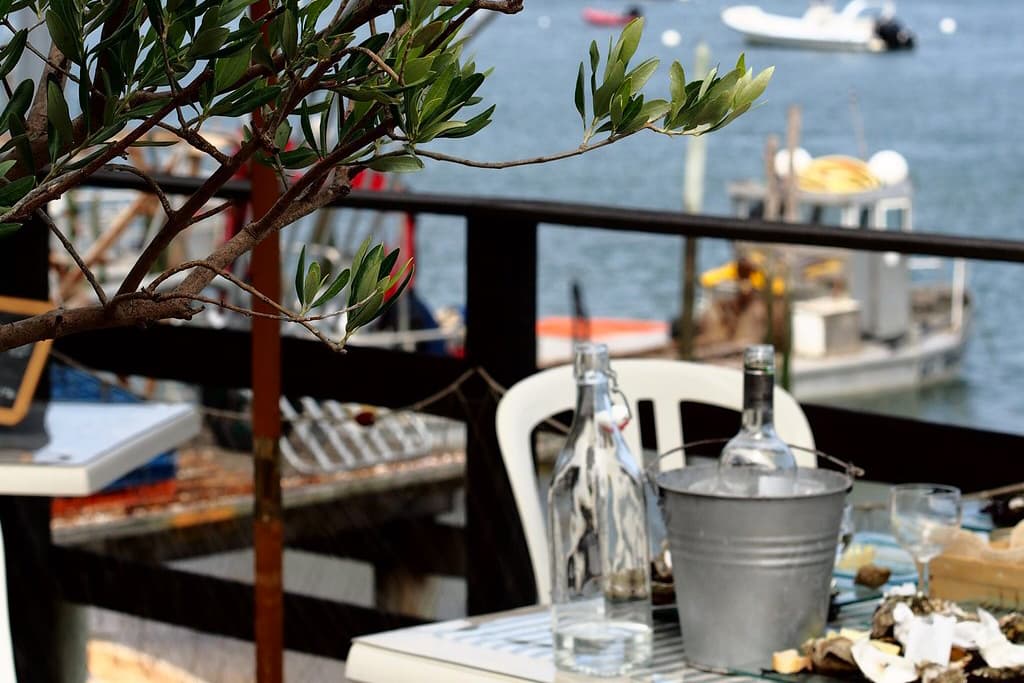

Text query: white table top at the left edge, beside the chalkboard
(0, 401), (201, 496)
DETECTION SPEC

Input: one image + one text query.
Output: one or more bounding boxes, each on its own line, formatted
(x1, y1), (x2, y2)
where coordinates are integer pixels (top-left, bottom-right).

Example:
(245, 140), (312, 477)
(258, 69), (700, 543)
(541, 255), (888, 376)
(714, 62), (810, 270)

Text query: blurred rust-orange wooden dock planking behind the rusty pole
(54, 449), (463, 561)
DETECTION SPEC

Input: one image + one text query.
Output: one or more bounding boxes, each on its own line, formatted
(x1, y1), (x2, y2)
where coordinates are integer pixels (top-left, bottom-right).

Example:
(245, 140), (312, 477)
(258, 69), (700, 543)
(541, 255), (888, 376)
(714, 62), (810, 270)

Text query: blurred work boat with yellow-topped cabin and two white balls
(696, 150), (971, 400)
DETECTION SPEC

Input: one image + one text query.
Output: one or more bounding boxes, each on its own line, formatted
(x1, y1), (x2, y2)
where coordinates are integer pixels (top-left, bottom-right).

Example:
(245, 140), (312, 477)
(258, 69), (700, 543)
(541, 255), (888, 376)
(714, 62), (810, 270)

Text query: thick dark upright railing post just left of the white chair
(465, 215), (537, 614)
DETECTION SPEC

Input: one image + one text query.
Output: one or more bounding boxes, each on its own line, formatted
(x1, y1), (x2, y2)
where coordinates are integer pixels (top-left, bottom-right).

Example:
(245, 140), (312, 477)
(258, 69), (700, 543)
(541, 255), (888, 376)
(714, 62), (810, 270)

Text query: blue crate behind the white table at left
(50, 362), (178, 493)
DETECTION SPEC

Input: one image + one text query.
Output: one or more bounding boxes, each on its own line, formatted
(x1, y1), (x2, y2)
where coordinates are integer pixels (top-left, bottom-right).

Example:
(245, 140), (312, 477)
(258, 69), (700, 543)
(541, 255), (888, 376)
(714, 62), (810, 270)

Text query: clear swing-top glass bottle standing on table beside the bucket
(548, 343), (651, 676)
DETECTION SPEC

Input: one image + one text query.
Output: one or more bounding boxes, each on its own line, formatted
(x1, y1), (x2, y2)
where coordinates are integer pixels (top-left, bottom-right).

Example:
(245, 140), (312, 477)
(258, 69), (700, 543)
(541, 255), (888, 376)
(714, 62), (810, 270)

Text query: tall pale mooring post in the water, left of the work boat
(679, 41), (711, 360)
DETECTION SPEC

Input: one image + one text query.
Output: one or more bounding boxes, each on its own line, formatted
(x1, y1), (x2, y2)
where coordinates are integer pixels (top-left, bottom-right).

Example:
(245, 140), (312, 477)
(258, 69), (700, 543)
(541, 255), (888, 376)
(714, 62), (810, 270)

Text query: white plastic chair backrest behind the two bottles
(496, 359), (816, 604)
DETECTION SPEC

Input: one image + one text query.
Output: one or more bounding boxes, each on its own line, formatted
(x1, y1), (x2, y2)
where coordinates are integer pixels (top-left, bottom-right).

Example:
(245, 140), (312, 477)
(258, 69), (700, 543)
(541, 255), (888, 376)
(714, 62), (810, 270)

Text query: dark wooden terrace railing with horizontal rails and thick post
(6, 169), (1024, 671)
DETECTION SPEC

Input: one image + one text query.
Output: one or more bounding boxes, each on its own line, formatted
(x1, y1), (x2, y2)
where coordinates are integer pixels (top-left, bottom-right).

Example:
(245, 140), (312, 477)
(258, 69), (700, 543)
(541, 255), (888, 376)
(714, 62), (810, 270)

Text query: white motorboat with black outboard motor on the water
(722, 0), (914, 52)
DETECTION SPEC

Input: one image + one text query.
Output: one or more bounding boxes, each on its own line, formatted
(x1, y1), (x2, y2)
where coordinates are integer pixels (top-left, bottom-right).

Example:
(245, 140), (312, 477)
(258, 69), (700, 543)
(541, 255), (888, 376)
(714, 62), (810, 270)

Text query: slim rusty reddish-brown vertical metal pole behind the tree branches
(250, 0), (285, 683)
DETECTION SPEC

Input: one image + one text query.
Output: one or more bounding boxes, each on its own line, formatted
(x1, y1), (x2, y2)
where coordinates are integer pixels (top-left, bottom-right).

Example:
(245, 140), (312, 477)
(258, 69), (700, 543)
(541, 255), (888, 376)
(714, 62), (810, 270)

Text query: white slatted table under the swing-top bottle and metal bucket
(345, 600), (878, 683)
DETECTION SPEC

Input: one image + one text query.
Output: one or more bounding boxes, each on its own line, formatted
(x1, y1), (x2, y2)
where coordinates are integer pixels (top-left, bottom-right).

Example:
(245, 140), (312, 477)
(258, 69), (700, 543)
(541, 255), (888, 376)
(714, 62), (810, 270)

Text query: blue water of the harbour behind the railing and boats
(407, 0), (1024, 432)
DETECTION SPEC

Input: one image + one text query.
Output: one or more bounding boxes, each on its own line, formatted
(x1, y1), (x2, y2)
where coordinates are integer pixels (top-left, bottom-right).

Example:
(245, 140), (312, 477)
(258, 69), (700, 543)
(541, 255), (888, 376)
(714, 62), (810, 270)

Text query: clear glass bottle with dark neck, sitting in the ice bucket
(719, 344), (797, 497)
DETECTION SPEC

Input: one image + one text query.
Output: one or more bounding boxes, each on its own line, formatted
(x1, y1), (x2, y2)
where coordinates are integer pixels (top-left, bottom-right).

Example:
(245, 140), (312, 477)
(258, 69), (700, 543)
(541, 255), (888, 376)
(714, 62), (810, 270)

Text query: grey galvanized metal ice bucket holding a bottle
(656, 465), (852, 672)
